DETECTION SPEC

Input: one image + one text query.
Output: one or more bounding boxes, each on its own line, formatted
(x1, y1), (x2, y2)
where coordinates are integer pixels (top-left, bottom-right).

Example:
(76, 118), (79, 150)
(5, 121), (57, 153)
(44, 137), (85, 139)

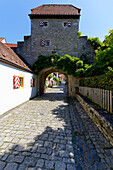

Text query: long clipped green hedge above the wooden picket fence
(80, 73), (113, 90)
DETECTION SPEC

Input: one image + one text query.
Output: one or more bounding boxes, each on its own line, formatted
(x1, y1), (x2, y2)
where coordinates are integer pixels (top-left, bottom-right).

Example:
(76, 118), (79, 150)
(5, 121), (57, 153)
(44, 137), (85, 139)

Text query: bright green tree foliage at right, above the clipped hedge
(84, 30), (113, 76)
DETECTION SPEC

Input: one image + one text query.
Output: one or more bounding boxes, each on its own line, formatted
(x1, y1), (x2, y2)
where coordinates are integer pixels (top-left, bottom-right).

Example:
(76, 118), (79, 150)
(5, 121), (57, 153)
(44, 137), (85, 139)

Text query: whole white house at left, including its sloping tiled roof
(0, 43), (37, 115)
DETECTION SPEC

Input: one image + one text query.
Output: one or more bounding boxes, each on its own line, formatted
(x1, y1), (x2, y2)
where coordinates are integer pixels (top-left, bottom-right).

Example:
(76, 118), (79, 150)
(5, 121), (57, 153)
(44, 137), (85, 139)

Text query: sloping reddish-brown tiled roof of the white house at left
(0, 42), (32, 72)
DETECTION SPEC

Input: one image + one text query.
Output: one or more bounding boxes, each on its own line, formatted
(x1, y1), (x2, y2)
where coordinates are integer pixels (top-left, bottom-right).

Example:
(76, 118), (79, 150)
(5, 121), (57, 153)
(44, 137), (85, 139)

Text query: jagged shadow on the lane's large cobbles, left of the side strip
(0, 99), (75, 170)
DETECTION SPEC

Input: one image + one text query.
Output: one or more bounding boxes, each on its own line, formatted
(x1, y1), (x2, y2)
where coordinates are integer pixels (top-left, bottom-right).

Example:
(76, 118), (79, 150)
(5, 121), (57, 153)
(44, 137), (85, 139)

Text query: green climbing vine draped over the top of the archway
(33, 54), (84, 76)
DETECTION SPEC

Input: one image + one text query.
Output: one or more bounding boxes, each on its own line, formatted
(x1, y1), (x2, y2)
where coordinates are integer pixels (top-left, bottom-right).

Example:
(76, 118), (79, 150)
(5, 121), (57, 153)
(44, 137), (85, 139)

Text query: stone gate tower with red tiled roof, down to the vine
(16, 5), (94, 66)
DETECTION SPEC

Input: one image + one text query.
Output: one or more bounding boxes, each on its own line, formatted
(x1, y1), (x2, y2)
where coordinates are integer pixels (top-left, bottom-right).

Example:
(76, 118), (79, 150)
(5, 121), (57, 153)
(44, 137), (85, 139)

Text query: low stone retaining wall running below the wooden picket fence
(75, 94), (113, 145)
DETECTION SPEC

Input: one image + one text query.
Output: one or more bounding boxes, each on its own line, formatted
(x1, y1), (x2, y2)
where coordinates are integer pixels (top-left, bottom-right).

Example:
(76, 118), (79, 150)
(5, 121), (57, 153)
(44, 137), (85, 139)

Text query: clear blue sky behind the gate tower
(0, 0), (113, 43)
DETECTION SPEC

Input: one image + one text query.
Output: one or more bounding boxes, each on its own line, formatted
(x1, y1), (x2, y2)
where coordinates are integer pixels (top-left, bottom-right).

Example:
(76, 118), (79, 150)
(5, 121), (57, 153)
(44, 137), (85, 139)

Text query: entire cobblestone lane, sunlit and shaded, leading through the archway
(0, 86), (113, 170)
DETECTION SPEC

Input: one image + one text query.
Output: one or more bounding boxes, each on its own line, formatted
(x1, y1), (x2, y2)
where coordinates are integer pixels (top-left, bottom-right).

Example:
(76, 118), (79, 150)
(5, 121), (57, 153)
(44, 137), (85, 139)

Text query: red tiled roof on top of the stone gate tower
(31, 5), (81, 15)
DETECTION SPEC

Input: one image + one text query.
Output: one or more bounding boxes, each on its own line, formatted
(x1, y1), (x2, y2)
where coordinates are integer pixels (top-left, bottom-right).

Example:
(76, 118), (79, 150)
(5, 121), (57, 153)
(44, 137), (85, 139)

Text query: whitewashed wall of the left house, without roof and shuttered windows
(0, 62), (37, 115)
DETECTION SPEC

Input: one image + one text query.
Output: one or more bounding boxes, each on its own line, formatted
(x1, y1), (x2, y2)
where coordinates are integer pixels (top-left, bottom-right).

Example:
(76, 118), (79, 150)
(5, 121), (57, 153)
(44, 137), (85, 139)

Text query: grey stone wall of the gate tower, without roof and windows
(16, 19), (95, 66)
